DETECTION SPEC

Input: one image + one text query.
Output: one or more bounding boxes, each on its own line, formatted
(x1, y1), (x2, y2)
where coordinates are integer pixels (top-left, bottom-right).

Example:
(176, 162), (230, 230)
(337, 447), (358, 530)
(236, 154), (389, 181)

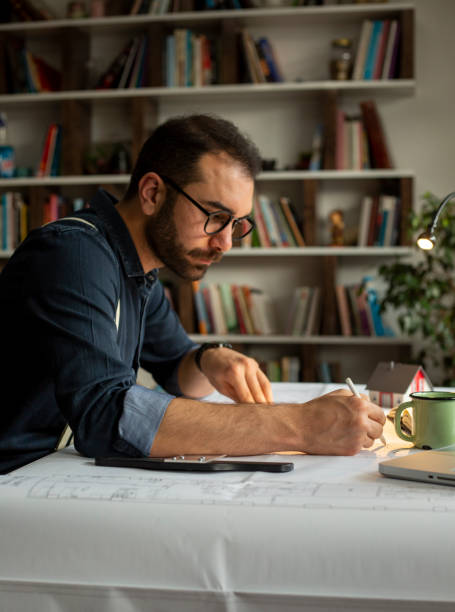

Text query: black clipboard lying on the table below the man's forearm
(95, 456), (294, 472)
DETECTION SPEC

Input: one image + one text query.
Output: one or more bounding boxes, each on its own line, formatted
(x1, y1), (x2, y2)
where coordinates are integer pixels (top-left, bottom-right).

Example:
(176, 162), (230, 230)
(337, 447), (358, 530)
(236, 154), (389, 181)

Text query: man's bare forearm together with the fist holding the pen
(150, 389), (385, 457)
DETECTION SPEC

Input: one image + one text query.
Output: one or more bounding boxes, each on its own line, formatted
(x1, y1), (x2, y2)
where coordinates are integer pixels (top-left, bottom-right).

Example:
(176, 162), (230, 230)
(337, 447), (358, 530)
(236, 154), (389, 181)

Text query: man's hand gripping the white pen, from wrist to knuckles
(301, 389), (386, 455)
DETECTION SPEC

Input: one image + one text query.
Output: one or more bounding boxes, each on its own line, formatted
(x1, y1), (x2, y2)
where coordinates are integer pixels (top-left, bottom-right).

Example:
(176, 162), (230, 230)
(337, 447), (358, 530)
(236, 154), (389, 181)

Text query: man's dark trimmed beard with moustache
(145, 201), (223, 281)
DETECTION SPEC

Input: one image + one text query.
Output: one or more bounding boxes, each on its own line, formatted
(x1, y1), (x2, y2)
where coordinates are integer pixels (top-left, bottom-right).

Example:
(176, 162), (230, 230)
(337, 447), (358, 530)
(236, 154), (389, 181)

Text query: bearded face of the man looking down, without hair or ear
(146, 154), (254, 280)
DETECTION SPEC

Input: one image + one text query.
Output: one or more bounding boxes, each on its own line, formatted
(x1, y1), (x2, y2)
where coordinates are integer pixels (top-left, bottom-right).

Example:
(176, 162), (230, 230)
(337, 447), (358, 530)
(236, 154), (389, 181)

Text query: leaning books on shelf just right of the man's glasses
(241, 194), (305, 247)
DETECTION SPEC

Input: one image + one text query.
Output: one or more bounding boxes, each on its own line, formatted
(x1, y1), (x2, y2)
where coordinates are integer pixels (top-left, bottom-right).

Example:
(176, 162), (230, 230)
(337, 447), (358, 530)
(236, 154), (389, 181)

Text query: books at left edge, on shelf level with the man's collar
(0, 191), (29, 251)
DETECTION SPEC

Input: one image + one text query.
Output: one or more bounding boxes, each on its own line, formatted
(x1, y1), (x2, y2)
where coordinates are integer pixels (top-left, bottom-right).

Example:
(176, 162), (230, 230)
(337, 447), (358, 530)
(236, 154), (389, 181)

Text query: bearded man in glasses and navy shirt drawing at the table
(0, 115), (385, 472)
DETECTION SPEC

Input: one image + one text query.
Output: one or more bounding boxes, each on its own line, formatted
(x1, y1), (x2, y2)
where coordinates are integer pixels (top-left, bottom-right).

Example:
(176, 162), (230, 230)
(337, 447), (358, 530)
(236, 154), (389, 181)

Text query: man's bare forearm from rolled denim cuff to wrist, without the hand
(150, 398), (303, 457)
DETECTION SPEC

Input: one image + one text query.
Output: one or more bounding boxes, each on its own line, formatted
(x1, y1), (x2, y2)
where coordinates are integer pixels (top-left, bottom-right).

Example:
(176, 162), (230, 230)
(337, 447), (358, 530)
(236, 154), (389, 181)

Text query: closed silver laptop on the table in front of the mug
(379, 446), (455, 487)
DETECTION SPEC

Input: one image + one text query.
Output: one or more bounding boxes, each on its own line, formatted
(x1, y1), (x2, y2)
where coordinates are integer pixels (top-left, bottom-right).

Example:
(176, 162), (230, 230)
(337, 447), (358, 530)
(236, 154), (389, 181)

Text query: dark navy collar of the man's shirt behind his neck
(90, 189), (158, 281)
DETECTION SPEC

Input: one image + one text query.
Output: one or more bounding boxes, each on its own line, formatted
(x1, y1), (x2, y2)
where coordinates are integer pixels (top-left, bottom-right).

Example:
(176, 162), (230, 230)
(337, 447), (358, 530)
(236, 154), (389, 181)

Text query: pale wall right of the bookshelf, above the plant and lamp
(381, 0), (455, 198)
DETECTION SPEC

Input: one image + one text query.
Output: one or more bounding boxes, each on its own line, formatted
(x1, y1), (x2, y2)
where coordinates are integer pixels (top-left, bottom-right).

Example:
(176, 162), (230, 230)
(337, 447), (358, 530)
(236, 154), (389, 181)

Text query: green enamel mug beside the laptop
(395, 391), (455, 449)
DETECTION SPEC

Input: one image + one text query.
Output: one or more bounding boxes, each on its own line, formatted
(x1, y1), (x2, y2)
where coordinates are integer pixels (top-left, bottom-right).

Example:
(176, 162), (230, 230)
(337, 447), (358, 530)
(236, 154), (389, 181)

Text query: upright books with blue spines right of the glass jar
(352, 19), (400, 80)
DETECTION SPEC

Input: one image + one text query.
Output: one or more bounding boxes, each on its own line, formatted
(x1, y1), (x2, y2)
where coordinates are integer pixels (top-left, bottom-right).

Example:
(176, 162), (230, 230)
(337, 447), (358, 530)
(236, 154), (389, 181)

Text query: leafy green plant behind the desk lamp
(379, 193), (455, 386)
